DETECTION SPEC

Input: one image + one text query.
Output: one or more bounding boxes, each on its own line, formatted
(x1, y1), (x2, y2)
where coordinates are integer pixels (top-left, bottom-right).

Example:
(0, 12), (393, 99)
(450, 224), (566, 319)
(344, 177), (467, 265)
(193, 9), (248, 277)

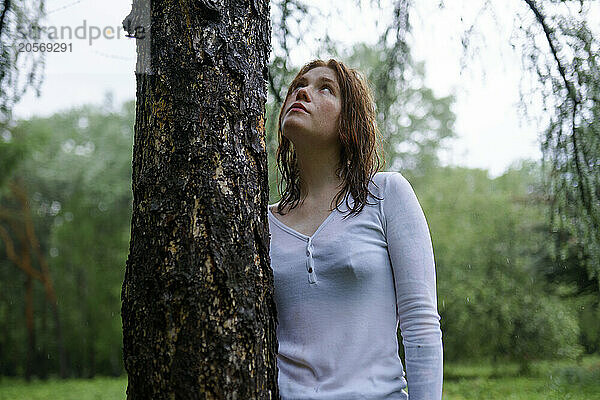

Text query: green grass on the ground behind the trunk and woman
(0, 356), (600, 400)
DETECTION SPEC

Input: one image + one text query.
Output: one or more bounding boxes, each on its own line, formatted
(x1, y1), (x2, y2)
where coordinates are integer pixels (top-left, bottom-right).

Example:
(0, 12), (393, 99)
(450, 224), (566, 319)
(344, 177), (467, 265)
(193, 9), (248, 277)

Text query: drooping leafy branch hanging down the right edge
(524, 0), (600, 284)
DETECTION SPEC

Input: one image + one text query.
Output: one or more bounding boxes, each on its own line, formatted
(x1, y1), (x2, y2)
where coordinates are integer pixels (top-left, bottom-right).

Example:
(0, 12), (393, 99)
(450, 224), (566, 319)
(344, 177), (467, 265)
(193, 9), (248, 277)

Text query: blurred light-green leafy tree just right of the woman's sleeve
(415, 164), (582, 372)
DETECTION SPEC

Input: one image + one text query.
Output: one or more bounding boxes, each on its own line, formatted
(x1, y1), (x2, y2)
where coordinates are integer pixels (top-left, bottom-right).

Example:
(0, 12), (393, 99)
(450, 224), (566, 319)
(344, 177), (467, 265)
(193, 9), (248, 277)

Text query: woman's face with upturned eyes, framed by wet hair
(281, 67), (342, 145)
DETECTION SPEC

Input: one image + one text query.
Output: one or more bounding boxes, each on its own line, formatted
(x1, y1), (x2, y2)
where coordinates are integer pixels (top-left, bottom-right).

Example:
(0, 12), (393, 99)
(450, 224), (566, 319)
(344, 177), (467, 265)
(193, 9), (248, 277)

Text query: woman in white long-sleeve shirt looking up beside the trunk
(268, 60), (442, 400)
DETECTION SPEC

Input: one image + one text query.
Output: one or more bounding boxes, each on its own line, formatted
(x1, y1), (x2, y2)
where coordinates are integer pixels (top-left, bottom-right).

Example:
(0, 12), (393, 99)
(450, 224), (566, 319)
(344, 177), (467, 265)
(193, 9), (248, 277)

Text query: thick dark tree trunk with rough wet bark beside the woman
(122, 0), (279, 399)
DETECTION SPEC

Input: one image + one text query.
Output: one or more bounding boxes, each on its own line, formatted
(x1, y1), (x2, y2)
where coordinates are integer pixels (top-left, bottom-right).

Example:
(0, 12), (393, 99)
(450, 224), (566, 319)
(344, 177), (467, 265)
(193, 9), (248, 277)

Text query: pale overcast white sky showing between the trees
(15, 0), (600, 177)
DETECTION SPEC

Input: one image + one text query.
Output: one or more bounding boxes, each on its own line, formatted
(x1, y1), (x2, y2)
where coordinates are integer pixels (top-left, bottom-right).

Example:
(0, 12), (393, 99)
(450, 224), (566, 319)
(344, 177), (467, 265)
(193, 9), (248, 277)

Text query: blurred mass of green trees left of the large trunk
(0, 102), (134, 377)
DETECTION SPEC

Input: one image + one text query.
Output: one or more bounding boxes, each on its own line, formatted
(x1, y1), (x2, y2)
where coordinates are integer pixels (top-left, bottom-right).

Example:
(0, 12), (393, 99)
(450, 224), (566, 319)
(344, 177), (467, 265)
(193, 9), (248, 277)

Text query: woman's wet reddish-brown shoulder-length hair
(276, 59), (385, 219)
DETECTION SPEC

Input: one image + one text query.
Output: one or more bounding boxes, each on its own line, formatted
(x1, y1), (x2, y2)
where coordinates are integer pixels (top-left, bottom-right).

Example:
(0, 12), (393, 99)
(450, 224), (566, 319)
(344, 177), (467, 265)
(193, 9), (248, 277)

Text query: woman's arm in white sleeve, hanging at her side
(382, 172), (443, 400)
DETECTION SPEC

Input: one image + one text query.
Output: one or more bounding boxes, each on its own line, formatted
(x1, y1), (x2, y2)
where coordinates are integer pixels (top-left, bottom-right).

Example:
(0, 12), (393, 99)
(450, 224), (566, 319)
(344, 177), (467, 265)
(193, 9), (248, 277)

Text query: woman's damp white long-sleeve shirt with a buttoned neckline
(268, 172), (442, 400)
